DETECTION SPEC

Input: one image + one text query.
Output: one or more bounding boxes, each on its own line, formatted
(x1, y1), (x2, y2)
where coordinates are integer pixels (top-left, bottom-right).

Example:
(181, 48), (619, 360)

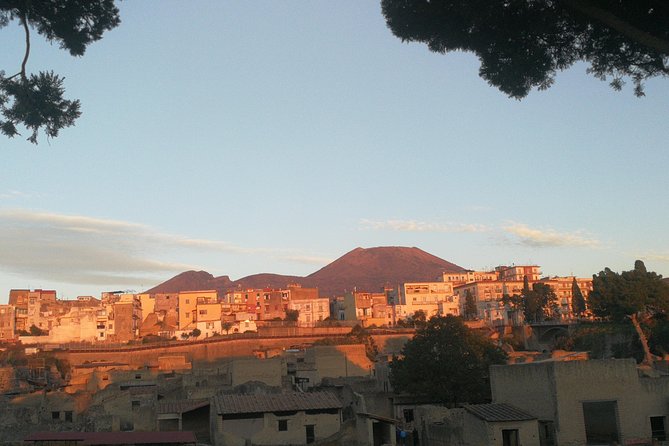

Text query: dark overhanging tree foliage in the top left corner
(0, 0), (120, 144)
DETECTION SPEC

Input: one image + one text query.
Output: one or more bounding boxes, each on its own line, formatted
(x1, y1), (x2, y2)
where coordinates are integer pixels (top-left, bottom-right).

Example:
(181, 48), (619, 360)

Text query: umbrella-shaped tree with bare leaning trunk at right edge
(588, 260), (669, 365)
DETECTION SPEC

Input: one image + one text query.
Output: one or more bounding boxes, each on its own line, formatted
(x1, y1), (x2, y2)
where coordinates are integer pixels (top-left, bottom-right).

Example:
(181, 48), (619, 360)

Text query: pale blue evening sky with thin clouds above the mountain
(0, 0), (669, 303)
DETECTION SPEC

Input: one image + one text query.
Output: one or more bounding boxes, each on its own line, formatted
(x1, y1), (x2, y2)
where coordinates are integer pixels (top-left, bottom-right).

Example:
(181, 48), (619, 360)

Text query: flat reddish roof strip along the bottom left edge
(23, 431), (197, 445)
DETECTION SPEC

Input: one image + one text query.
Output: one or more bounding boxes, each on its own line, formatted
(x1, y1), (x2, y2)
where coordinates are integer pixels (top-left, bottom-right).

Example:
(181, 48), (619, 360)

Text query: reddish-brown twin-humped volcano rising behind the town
(146, 246), (465, 296)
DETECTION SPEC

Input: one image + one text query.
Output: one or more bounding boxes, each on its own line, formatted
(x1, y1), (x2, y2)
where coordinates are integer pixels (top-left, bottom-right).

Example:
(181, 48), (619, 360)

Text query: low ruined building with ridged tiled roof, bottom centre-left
(211, 392), (343, 446)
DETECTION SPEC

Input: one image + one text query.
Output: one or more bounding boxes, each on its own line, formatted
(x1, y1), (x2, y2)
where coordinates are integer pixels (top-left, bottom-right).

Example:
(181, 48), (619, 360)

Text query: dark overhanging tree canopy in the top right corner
(381, 0), (669, 99)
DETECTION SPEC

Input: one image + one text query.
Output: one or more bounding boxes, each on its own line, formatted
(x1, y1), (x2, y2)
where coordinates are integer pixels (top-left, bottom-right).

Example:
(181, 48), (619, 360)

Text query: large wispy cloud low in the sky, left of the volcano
(0, 209), (327, 285)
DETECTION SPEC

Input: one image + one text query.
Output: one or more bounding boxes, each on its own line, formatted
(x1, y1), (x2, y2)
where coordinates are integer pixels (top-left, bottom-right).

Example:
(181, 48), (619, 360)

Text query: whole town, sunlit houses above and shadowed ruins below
(0, 254), (669, 446)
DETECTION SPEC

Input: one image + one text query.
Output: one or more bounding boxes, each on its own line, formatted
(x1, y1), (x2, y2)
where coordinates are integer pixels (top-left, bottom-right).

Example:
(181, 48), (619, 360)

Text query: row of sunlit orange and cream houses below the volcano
(0, 265), (592, 343)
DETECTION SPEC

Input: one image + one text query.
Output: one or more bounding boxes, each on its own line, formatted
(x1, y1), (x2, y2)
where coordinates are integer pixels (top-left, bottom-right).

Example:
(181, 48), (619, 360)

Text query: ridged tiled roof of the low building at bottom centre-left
(214, 392), (343, 415)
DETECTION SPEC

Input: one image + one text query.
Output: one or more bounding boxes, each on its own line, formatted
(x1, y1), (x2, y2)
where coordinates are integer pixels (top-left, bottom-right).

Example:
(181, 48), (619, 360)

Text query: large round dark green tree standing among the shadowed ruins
(390, 315), (506, 406)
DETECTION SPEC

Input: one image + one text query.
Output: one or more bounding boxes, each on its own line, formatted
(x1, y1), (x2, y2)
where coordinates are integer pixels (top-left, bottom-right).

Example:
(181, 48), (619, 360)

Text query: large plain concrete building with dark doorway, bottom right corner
(490, 359), (669, 446)
